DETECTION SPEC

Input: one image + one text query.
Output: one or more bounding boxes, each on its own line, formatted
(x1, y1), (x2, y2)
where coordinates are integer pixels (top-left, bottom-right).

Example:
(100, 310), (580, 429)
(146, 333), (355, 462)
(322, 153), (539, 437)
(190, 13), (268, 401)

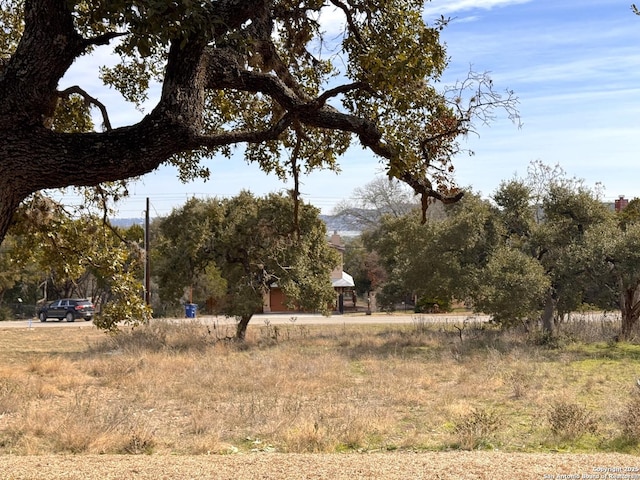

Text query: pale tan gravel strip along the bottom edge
(0, 452), (640, 480)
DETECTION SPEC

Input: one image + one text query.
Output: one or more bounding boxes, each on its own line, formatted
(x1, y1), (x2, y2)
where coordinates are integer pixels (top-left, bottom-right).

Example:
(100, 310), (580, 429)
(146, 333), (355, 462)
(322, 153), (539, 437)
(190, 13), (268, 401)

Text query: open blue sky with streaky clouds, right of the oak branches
(428, 0), (640, 199)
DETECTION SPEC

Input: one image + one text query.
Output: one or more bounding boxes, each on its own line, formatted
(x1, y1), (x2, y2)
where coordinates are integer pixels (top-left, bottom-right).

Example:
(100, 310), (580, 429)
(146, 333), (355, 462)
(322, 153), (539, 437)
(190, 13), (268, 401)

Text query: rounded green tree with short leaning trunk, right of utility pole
(155, 192), (339, 339)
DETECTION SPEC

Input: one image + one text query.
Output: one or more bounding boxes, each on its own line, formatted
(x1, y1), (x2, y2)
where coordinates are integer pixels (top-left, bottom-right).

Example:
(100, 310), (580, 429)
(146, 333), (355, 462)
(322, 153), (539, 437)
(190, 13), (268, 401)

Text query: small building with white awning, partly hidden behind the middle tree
(262, 232), (356, 313)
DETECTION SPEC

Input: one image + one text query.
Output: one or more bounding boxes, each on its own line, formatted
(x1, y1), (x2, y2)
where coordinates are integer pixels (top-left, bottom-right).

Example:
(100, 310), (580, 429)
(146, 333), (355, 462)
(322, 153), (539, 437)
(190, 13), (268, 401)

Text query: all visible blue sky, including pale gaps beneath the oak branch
(61, 0), (640, 217)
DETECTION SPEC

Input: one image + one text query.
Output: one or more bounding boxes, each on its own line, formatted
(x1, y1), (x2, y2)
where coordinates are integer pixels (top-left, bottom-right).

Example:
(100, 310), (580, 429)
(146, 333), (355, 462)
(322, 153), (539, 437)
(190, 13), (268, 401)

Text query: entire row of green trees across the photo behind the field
(5, 162), (640, 338)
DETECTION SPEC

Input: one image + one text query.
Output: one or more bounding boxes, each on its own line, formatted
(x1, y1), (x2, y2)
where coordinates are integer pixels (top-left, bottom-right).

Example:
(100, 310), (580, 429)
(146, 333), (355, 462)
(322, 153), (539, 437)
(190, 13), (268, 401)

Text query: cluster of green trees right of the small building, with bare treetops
(341, 161), (640, 338)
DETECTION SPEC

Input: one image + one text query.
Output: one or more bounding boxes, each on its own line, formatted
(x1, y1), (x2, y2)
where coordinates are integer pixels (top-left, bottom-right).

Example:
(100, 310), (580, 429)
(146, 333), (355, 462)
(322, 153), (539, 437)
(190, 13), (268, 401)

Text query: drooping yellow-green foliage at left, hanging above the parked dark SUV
(6, 194), (151, 330)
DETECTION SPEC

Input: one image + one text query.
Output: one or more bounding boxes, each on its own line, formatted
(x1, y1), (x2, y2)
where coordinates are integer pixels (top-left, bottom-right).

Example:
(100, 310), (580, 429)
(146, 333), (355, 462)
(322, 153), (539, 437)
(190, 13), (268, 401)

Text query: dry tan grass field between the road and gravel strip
(0, 317), (640, 478)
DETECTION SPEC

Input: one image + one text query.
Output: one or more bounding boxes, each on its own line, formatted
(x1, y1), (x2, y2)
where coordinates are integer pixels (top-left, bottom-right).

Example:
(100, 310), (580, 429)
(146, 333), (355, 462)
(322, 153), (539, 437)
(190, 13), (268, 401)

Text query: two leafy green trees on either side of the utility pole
(0, 192), (339, 338)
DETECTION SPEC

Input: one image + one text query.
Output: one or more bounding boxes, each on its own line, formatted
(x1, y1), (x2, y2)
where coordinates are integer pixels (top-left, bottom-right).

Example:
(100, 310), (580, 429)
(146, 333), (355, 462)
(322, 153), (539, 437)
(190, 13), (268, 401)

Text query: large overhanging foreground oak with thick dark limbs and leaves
(0, 0), (517, 244)
